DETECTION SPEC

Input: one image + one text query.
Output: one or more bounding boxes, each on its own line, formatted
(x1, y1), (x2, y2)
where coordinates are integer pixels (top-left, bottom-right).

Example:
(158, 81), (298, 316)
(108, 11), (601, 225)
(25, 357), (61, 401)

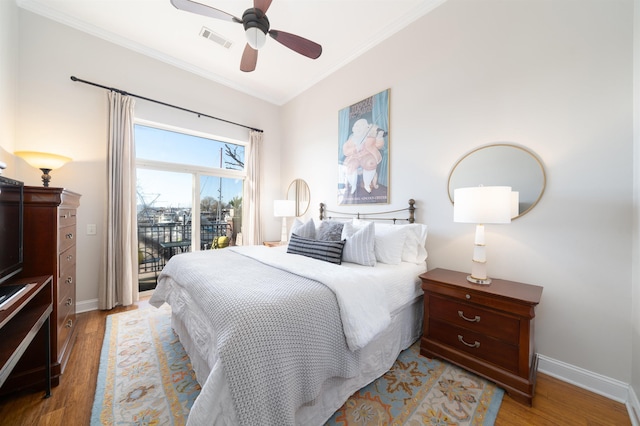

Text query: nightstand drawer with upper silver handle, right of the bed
(428, 295), (520, 345)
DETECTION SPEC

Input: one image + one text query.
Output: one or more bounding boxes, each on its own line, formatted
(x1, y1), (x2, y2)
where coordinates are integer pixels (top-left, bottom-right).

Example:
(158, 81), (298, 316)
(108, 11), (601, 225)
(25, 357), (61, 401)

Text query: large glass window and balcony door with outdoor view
(134, 124), (246, 291)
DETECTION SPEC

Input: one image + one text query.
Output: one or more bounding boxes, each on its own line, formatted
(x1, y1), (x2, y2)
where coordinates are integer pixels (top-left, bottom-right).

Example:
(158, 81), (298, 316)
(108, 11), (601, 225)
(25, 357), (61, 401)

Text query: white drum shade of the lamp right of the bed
(453, 186), (513, 224)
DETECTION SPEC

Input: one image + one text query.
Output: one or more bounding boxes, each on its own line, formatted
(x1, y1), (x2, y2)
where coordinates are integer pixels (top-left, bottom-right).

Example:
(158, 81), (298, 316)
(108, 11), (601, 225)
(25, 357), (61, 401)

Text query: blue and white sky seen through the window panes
(135, 124), (244, 208)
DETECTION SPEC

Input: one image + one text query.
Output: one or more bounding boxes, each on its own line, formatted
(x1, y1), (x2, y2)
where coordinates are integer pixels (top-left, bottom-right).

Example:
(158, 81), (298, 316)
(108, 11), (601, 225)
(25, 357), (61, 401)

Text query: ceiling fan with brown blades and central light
(171, 0), (322, 72)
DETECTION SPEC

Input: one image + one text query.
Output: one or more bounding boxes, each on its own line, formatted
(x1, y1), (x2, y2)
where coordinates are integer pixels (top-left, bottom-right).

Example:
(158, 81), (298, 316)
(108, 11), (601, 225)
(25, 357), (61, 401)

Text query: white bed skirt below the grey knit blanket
(171, 296), (424, 426)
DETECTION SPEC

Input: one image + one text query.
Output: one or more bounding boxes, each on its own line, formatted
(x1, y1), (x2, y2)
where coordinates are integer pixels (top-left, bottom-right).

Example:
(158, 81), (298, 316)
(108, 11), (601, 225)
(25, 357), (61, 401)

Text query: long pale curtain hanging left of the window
(98, 92), (138, 309)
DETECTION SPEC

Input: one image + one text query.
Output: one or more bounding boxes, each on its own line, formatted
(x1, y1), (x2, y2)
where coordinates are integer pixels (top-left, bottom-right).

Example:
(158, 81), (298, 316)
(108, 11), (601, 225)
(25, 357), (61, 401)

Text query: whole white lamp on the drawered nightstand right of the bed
(453, 186), (518, 284)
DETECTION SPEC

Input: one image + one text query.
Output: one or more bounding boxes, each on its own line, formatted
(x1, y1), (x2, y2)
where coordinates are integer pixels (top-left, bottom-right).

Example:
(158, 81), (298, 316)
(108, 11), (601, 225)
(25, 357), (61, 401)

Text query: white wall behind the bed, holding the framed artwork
(282, 0), (633, 383)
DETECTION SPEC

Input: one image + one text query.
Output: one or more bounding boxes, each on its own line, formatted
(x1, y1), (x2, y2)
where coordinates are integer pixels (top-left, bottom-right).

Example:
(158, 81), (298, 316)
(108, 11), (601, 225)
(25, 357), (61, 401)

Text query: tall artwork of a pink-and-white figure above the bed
(338, 89), (389, 204)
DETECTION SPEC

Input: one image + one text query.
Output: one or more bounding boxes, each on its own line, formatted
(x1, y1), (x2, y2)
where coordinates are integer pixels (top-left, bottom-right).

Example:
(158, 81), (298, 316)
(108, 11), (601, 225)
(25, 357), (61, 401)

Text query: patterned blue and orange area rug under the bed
(91, 305), (504, 426)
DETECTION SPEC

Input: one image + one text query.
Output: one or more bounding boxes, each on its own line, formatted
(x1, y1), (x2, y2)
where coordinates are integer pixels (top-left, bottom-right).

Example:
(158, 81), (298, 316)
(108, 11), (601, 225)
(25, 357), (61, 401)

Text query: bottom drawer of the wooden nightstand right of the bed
(427, 318), (518, 373)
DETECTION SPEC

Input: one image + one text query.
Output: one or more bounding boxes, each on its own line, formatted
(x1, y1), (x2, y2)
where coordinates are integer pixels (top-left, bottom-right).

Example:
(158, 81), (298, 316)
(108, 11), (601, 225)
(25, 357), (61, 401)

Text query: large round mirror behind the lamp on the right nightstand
(448, 144), (547, 219)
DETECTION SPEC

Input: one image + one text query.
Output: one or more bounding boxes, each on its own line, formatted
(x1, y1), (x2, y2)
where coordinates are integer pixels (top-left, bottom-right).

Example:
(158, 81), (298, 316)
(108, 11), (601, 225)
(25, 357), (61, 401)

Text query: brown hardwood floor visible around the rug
(0, 300), (631, 426)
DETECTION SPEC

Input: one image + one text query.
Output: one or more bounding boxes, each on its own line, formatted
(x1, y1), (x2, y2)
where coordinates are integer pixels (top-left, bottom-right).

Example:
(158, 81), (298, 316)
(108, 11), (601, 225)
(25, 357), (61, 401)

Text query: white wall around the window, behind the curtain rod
(6, 10), (281, 309)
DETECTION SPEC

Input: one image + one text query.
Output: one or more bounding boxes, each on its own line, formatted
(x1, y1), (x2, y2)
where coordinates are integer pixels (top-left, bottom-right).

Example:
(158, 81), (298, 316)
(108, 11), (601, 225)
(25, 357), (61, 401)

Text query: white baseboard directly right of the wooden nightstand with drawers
(538, 355), (632, 404)
